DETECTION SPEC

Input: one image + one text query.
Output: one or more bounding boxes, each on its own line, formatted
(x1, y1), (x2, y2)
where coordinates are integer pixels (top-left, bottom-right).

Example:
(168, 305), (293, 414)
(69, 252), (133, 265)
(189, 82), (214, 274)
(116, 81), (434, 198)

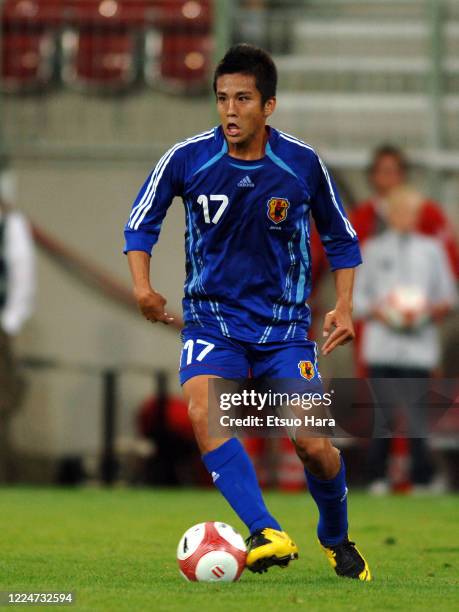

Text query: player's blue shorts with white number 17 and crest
(180, 328), (320, 385)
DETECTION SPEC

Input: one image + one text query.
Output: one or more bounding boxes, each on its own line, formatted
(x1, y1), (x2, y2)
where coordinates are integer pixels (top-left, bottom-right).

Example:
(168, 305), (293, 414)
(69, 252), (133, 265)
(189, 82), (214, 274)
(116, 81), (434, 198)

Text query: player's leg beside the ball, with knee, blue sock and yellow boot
(183, 375), (298, 573)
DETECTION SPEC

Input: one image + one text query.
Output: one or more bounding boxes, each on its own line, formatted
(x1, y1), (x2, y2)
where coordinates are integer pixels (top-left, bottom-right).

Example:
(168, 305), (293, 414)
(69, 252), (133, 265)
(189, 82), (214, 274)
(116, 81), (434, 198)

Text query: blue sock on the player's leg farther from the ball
(304, 457), (348, 546)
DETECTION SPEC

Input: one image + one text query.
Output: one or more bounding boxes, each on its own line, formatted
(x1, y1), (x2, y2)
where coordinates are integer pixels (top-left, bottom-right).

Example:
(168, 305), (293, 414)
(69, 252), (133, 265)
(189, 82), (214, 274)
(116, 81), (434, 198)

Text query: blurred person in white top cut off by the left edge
(0, 202), (36, 482)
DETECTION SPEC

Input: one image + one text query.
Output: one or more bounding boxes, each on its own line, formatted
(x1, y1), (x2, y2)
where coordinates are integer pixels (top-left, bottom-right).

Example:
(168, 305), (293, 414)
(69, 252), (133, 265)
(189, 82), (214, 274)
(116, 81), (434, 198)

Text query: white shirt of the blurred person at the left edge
(0, 211), (36, 335)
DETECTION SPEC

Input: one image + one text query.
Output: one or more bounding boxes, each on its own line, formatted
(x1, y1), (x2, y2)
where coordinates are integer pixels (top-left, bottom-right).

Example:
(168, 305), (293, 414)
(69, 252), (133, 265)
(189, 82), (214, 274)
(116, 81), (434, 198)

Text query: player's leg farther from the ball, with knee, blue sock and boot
(294, 437), (371, 581)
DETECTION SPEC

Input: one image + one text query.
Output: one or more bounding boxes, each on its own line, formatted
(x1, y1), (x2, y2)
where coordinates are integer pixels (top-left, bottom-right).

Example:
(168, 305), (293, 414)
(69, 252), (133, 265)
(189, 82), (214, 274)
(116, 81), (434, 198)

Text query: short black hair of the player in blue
(213, 43), (277, 104)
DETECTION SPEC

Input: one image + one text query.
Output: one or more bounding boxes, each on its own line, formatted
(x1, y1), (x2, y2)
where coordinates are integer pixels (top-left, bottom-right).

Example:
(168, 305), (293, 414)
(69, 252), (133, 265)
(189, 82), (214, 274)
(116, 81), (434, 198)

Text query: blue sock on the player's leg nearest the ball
(202, 438), (281, 533)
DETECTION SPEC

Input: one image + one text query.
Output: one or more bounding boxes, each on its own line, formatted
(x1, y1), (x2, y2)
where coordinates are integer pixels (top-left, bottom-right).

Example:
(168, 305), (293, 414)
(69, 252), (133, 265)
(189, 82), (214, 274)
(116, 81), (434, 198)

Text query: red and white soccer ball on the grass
(177, 522), (247, 582)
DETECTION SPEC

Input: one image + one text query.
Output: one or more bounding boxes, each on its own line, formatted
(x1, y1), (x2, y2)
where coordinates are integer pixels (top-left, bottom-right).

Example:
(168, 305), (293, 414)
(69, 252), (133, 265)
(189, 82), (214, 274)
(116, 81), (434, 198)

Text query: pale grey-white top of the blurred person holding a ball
(354, 230), (457, 370)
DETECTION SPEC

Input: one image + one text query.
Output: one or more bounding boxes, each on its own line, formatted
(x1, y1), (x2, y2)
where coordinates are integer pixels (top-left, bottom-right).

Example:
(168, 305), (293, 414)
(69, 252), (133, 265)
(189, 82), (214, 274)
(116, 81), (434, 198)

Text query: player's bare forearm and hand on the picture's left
(127, 251), (174, 324)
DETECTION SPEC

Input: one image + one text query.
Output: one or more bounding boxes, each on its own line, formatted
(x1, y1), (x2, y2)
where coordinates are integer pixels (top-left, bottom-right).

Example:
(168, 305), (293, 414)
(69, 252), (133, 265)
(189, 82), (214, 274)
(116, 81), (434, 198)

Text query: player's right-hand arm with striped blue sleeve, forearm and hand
(311, 157), (362, 355)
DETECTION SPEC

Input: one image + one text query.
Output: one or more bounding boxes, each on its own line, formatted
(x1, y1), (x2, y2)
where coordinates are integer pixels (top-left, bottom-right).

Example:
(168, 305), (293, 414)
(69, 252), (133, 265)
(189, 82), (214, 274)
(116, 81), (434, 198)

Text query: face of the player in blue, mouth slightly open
(217, 73), (276, 150)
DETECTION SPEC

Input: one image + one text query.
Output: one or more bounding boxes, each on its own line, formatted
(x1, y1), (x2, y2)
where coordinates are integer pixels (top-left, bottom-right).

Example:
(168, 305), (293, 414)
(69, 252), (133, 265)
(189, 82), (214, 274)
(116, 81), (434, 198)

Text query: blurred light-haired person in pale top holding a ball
(354, 186), (457, 494)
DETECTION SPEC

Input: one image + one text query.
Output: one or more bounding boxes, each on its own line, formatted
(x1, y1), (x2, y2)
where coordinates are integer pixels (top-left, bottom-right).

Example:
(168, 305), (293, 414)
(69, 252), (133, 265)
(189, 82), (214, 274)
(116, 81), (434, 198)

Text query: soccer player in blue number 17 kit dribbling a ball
(125, 44), (371, 580)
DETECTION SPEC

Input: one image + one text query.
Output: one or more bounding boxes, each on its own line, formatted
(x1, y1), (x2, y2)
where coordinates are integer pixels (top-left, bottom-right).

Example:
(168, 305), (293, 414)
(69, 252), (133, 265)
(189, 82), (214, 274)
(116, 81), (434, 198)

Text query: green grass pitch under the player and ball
(0, 488), (459, 612)
